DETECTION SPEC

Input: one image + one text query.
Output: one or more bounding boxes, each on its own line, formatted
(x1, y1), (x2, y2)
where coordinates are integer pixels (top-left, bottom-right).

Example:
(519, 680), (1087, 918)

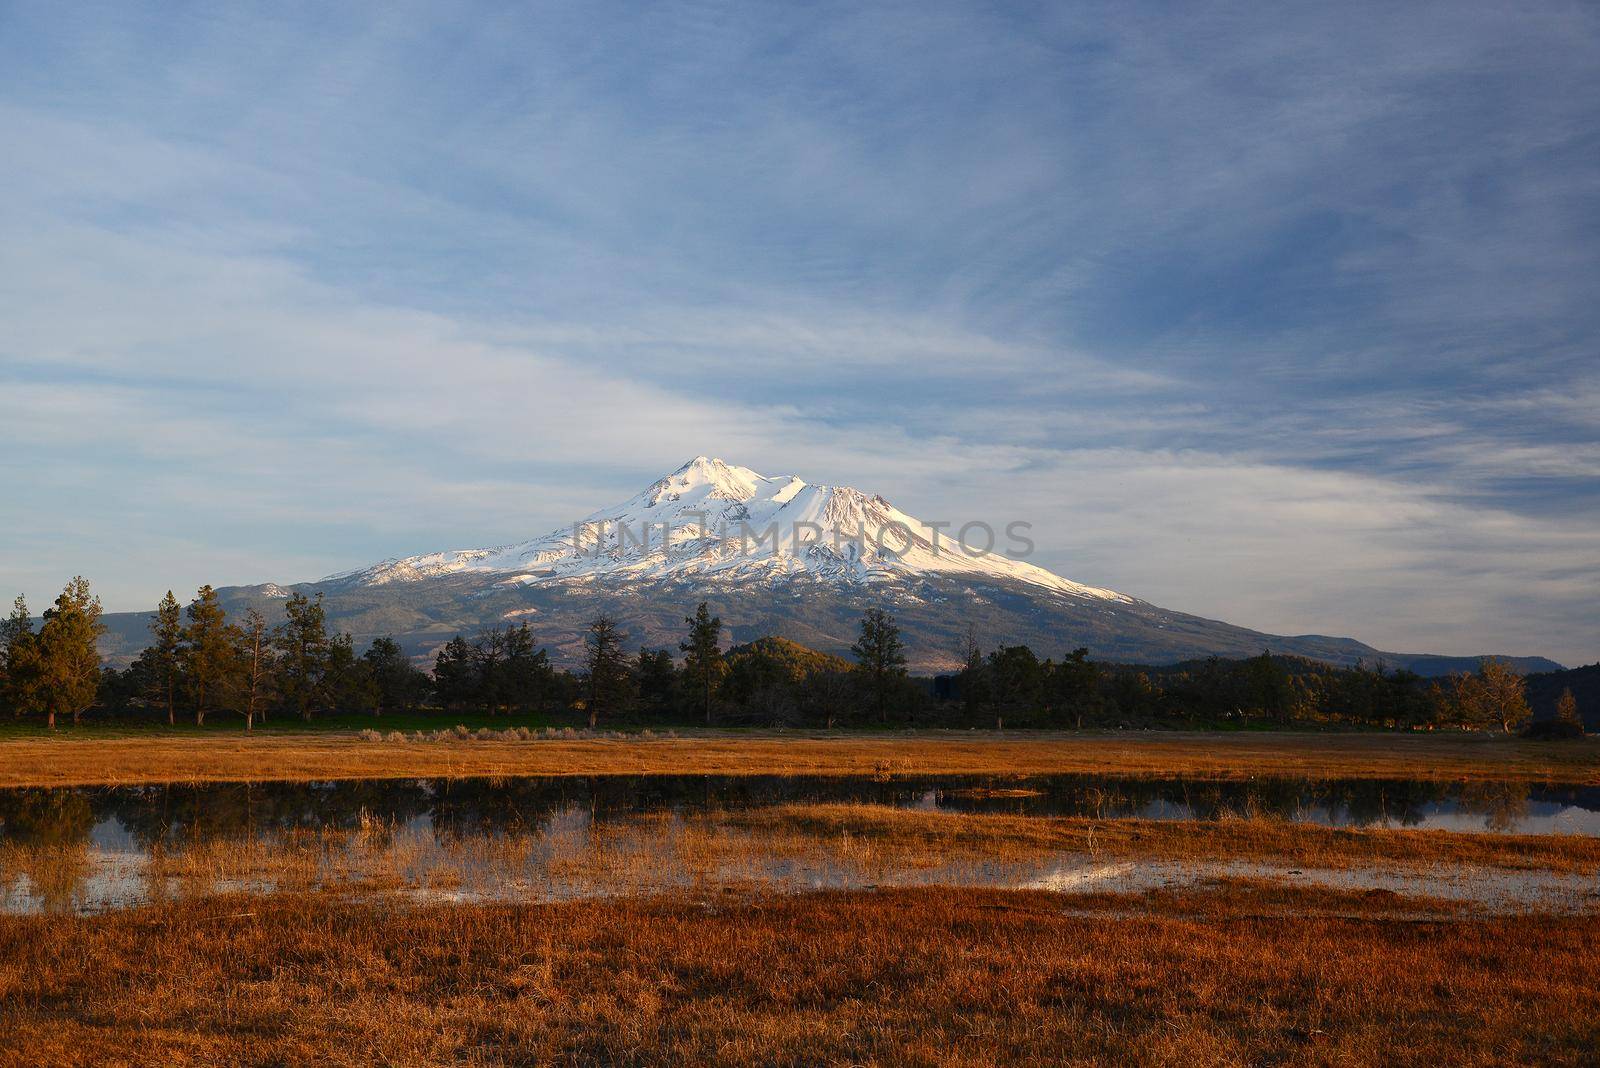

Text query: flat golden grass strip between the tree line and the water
(0, 732), (1600, 787)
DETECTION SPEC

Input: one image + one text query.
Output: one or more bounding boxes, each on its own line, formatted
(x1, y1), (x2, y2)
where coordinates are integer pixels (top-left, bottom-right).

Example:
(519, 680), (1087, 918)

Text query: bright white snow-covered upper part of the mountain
(326, 456), (1133, 604)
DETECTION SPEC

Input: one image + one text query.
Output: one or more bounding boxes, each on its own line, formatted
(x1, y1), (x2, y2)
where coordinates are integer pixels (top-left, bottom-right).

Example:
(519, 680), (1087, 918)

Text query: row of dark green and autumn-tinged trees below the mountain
(0, 577), (1582, 734)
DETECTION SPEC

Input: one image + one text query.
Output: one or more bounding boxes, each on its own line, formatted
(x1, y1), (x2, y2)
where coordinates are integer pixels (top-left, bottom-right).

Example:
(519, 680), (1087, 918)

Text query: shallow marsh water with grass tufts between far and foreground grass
(0, 775), (1600, 911)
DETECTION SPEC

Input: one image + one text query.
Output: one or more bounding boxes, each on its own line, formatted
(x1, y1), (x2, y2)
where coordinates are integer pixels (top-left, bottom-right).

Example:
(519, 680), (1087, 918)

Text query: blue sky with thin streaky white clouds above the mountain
(0, 0), (1600, 664)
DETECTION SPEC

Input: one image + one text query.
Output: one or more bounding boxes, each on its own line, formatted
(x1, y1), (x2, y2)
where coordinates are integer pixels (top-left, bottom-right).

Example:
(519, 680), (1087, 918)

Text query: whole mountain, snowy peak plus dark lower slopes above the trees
(87, 456), (1558, 675)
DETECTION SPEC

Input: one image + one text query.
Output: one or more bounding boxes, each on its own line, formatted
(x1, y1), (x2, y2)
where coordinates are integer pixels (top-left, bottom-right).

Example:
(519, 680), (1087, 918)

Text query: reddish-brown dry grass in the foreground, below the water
(0, 884), (1600, 1066)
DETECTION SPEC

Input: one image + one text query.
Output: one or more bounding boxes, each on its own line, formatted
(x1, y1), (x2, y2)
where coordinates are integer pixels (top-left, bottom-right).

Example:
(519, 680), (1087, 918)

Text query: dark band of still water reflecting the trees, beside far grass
(0, 775), (1600, 851)
